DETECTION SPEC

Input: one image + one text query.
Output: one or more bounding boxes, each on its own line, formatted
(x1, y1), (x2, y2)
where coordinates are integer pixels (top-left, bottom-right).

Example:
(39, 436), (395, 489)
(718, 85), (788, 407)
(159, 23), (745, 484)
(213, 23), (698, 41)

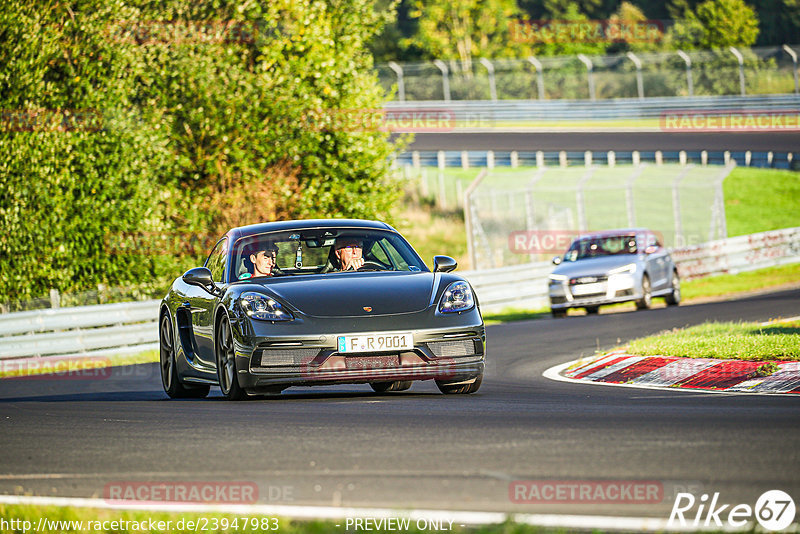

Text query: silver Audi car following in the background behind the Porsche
(549, 228), (681, 317)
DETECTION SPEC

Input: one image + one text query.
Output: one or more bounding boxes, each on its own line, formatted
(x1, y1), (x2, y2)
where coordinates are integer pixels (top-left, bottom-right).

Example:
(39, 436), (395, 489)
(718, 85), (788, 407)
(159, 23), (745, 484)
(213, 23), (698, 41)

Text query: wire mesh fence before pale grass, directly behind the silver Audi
(465, 163), (733, 269)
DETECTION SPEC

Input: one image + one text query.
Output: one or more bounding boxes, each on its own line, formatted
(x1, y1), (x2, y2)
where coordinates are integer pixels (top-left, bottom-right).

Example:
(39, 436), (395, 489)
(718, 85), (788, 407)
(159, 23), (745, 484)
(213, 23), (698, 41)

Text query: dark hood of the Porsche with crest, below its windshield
(255, 272), (434, 317)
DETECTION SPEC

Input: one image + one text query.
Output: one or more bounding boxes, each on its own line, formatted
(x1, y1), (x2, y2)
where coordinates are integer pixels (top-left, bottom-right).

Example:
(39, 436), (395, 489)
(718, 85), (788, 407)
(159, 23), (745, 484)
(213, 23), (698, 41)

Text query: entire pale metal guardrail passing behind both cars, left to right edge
(0, 227), (800, 360)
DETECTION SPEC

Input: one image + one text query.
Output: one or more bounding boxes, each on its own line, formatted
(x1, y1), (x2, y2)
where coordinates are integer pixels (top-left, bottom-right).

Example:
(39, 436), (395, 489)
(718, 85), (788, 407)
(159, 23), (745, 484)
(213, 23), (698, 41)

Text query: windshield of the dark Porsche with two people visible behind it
(232, 228), (428, 280)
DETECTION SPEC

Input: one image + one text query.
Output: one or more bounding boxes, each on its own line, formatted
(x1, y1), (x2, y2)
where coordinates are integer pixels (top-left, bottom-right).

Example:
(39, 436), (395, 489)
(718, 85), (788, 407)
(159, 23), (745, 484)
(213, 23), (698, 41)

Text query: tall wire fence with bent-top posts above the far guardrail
(377, 45), (800, 101)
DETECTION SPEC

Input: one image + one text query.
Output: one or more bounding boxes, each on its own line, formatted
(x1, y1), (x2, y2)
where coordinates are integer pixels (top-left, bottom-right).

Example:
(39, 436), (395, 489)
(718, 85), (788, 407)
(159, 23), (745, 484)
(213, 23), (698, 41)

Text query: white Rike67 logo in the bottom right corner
(667, 490), (796, 531)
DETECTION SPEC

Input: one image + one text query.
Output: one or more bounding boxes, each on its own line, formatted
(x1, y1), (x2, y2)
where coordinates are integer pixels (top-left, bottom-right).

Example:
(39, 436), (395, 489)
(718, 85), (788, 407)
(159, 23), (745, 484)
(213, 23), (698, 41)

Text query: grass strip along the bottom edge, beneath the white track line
(0, 505), (564, 534)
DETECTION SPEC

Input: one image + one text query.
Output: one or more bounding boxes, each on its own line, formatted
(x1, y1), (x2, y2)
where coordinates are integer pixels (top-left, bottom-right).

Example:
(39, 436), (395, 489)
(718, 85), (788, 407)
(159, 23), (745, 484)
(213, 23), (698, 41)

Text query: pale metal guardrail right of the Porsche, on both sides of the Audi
(461, 227), (800, 311)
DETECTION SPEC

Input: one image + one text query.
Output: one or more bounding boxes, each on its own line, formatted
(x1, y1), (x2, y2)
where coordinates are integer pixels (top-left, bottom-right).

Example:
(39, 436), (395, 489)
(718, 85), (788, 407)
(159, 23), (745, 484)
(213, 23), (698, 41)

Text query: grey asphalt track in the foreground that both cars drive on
(0, 290), (800, 519)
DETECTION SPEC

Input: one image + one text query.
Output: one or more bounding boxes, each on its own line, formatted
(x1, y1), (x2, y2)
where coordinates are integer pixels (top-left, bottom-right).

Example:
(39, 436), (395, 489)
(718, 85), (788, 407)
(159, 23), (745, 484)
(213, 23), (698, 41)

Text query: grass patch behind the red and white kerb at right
(626, 321), (800, 361)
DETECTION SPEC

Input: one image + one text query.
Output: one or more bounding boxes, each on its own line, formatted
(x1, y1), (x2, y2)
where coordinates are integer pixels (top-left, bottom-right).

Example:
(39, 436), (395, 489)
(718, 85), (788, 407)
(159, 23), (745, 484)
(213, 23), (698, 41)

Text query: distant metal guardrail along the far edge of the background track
(385, 94), (800, 122)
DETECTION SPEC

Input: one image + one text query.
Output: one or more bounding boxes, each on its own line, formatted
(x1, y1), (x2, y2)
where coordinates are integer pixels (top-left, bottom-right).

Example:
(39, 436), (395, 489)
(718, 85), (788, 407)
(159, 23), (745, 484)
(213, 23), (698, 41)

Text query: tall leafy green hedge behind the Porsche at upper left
(0, 0), (397, 301)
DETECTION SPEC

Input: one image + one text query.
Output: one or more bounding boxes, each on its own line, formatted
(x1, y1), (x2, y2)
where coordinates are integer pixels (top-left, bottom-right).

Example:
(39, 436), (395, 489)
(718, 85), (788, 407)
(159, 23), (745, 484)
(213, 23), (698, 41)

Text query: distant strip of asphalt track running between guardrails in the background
(407, 131), (800, 152)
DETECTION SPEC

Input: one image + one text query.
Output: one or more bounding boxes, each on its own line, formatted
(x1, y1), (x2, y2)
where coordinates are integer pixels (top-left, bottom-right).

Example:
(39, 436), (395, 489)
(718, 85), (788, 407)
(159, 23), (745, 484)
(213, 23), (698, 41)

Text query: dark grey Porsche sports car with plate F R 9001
(159, 219), (486, 400)
